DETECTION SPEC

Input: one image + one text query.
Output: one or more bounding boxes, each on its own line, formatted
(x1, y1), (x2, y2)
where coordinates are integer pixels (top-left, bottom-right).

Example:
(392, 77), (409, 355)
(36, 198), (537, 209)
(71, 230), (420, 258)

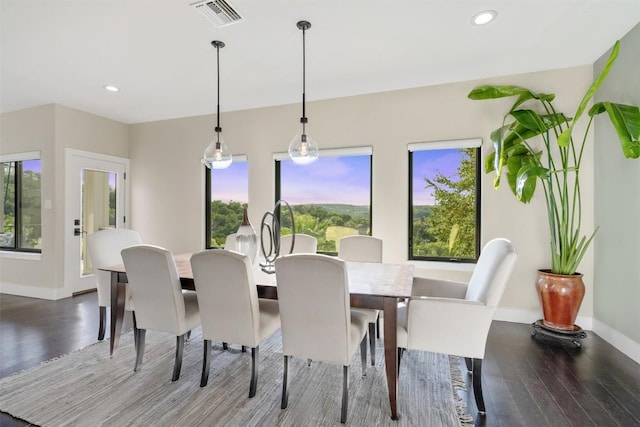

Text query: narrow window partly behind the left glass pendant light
(205, 156), (249, 249)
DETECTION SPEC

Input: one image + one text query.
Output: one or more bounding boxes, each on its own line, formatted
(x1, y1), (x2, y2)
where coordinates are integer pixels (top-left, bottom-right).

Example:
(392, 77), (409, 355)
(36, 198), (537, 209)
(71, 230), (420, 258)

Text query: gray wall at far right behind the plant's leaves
(594, 25), (640, 346)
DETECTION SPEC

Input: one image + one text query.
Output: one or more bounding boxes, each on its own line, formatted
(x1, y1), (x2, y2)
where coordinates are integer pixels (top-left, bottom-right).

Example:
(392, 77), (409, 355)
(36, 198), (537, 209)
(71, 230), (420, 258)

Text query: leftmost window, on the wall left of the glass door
(0, 153), (42, 252)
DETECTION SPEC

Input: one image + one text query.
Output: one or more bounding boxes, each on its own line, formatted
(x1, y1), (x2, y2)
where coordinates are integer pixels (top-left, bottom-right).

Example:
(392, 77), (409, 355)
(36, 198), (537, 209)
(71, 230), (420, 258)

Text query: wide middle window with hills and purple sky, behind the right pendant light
(275, 147), (372, 254)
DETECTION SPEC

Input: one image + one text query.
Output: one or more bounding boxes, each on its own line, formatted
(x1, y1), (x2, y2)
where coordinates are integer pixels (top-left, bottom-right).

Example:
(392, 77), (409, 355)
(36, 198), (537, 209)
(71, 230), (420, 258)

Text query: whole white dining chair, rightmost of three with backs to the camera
(275, 254), (367, 423)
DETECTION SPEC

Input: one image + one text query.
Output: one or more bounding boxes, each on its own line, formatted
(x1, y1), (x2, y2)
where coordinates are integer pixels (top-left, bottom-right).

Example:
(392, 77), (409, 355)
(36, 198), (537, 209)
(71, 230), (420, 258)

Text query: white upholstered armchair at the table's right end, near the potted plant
(398, 238), (518, 414)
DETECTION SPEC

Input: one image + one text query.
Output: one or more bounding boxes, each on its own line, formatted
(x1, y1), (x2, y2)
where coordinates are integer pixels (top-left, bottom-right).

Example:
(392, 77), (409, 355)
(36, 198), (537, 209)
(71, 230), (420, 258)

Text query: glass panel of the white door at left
(80, 169), (117, 276)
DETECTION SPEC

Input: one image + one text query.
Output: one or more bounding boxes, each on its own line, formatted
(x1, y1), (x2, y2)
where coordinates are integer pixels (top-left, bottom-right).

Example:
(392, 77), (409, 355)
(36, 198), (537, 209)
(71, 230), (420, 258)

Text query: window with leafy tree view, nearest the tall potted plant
(409, 139), (481, 262)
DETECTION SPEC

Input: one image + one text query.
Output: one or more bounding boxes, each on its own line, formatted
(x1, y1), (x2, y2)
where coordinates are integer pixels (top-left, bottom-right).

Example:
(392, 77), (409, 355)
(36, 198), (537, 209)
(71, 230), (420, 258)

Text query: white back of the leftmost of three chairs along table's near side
(122, 245), (190, 335)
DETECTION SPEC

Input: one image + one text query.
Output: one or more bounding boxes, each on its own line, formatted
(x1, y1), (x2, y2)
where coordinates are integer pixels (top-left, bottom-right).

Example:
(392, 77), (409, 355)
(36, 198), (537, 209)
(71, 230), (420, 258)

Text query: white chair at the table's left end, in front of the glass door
(87, 228), (142, 341)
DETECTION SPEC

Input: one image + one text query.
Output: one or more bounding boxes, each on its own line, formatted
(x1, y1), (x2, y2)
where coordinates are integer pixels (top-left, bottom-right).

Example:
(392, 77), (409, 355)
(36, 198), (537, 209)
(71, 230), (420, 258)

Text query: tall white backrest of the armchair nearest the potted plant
(465, 238), (518, 307)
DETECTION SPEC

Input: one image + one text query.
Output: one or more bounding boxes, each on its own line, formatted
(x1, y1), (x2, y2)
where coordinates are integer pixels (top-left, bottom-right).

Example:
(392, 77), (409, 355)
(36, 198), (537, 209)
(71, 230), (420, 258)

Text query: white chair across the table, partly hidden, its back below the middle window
(338, 235), (382, 366)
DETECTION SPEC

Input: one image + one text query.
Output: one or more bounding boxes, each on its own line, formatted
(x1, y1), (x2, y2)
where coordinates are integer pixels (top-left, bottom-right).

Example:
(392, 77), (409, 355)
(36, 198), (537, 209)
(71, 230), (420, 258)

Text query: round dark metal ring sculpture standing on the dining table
(260, 200), (296, 274)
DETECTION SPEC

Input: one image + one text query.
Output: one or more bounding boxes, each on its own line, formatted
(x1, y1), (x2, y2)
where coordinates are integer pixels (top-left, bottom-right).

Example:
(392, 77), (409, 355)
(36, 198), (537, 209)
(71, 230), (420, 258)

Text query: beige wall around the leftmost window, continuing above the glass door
(0, 104), (129, 299)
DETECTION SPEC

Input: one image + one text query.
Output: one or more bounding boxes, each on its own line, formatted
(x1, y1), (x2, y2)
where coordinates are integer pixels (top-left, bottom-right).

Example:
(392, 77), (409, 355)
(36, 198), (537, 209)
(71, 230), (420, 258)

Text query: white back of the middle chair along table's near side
(191, 249), (260, 347)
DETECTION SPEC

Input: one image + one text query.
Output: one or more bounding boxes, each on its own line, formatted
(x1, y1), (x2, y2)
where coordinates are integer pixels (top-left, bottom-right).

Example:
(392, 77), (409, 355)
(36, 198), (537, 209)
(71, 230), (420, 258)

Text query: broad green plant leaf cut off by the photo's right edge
(589, 102), (640, 159)
